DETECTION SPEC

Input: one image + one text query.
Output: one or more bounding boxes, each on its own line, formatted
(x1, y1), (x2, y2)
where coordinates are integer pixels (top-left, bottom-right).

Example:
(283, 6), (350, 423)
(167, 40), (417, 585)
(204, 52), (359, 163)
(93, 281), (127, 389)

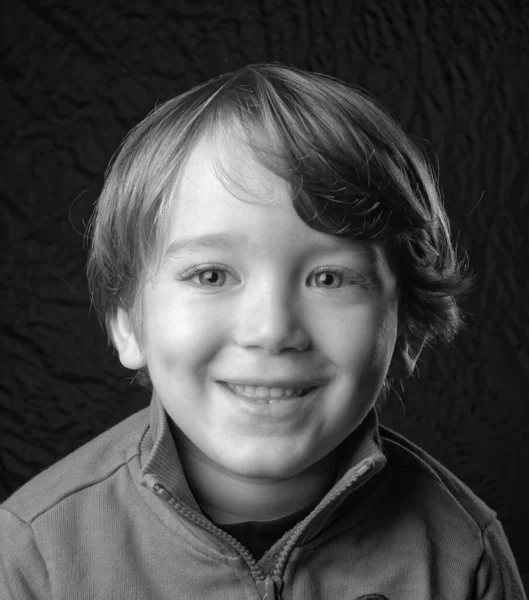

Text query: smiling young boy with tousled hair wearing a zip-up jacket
(0, 65), (525, 600)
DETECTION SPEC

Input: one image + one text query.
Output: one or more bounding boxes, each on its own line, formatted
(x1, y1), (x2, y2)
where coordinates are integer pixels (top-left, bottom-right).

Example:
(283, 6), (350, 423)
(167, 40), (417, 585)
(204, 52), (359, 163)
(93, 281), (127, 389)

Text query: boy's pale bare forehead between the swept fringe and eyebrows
(166, 132), (294, 243)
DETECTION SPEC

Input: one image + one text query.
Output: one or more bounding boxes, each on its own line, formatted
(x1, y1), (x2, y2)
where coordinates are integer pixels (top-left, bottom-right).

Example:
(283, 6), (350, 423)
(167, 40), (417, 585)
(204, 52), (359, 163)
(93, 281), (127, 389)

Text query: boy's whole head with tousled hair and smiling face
(88, 65), (467, 477)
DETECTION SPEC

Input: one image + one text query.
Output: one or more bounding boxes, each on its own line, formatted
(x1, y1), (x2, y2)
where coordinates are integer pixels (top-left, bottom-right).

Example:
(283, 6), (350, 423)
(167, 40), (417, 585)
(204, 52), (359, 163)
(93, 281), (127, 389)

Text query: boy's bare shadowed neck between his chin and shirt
(173, 440), (339, 524)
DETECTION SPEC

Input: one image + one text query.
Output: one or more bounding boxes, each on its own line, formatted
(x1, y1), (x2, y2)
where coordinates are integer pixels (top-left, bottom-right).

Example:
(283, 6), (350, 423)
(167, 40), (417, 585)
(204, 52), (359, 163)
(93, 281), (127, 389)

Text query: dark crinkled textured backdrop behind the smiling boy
(0, 0), (529, 585)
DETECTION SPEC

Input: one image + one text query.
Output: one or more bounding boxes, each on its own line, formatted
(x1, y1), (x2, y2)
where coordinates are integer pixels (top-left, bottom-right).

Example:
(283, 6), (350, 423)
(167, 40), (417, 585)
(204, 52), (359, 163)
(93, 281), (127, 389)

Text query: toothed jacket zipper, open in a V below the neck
(152, 458), (376, 600)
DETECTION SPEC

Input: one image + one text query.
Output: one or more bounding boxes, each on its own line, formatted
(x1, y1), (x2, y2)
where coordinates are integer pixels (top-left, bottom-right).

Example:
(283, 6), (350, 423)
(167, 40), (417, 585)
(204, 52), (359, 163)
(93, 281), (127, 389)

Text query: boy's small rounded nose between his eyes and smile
(235, 285), (310, 354)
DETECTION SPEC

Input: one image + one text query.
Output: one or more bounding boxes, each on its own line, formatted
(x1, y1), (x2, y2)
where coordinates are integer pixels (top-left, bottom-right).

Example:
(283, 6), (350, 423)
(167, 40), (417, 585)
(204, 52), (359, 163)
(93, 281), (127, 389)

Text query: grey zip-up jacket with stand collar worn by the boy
(0, 399), (525, 600)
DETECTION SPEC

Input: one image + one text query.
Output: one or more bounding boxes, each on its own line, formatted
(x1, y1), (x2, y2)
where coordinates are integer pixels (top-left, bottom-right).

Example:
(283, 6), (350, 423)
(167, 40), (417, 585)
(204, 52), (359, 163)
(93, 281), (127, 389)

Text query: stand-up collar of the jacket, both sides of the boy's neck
(141, 394), (386, 513)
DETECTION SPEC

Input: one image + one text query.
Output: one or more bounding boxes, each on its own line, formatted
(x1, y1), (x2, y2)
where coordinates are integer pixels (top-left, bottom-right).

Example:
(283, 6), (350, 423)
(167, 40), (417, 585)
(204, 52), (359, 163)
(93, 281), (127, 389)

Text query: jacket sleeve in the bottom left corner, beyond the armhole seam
(0, 508), (51, 600)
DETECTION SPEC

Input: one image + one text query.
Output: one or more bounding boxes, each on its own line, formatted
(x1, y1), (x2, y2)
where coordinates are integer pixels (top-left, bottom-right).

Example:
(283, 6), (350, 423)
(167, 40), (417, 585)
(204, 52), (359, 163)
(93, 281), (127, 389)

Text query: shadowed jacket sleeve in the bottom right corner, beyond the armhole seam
(475, 518), (527, 600)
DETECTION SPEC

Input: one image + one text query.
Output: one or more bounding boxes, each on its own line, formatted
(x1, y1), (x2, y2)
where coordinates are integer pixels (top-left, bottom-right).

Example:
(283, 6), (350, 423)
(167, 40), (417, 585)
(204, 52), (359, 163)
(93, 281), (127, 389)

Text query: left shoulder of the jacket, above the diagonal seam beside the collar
(0, 408), (149, 523)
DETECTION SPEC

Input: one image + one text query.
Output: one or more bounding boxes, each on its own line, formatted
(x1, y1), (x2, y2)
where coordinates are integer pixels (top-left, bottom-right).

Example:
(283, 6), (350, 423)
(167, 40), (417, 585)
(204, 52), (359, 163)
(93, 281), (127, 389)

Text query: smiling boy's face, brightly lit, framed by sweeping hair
(113, 134), (398, 480)
